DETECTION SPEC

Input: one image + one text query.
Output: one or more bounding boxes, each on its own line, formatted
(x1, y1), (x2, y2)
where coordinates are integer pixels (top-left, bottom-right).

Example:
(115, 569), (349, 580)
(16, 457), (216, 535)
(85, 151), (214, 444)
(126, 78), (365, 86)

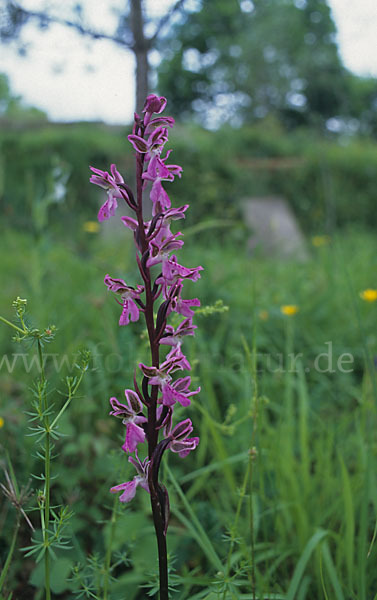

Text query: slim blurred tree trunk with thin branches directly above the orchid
(0, 0), (185, 111)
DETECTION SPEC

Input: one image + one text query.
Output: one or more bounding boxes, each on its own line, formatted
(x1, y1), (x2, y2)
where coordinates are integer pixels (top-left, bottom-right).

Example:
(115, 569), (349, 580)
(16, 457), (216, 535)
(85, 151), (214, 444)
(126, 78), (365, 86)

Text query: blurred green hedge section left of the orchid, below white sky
(0, 121), (127, 234)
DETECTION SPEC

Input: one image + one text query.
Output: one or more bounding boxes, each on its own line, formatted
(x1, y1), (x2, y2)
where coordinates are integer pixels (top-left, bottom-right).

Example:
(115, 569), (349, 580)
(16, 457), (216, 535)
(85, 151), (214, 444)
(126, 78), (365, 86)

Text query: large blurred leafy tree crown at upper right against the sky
(158, 0), (376, 132)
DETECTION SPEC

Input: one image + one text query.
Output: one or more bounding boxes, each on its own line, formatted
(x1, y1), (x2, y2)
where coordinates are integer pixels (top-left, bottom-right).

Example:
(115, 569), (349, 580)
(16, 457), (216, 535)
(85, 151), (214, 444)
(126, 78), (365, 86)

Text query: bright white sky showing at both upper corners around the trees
(0, 0), (377, 123)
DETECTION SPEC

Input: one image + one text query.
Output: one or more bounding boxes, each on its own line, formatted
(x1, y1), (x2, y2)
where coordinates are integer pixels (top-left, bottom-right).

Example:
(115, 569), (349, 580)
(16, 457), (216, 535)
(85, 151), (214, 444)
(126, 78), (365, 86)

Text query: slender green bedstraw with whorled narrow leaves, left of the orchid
(0, 297), (90, 600)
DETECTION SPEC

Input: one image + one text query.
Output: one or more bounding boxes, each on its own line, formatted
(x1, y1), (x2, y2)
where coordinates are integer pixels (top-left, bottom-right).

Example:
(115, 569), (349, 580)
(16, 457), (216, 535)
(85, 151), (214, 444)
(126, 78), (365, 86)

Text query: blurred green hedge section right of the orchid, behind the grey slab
(173, 119), (377, 231)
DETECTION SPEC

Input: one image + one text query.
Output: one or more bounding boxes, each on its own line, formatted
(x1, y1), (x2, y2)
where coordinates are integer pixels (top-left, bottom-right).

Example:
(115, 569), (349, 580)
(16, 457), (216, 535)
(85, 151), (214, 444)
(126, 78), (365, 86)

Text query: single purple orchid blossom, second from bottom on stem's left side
(110, 390), (147, 452)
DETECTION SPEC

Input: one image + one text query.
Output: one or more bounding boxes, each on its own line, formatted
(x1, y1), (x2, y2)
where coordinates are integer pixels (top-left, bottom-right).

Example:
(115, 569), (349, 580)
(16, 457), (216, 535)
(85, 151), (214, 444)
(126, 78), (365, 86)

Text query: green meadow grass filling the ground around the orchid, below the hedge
(0, 228), (377, 600)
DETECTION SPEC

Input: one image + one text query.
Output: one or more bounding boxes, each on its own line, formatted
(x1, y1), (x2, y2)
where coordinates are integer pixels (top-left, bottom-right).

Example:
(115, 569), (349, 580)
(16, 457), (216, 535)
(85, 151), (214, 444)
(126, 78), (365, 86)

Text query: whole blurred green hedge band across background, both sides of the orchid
(0, 119), (377, 239)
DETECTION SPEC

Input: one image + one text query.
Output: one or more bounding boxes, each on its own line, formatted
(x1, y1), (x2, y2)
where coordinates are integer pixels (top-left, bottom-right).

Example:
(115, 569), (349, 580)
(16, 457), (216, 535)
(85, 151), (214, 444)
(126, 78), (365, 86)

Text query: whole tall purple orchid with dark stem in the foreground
(90, 95), (202, 600)
